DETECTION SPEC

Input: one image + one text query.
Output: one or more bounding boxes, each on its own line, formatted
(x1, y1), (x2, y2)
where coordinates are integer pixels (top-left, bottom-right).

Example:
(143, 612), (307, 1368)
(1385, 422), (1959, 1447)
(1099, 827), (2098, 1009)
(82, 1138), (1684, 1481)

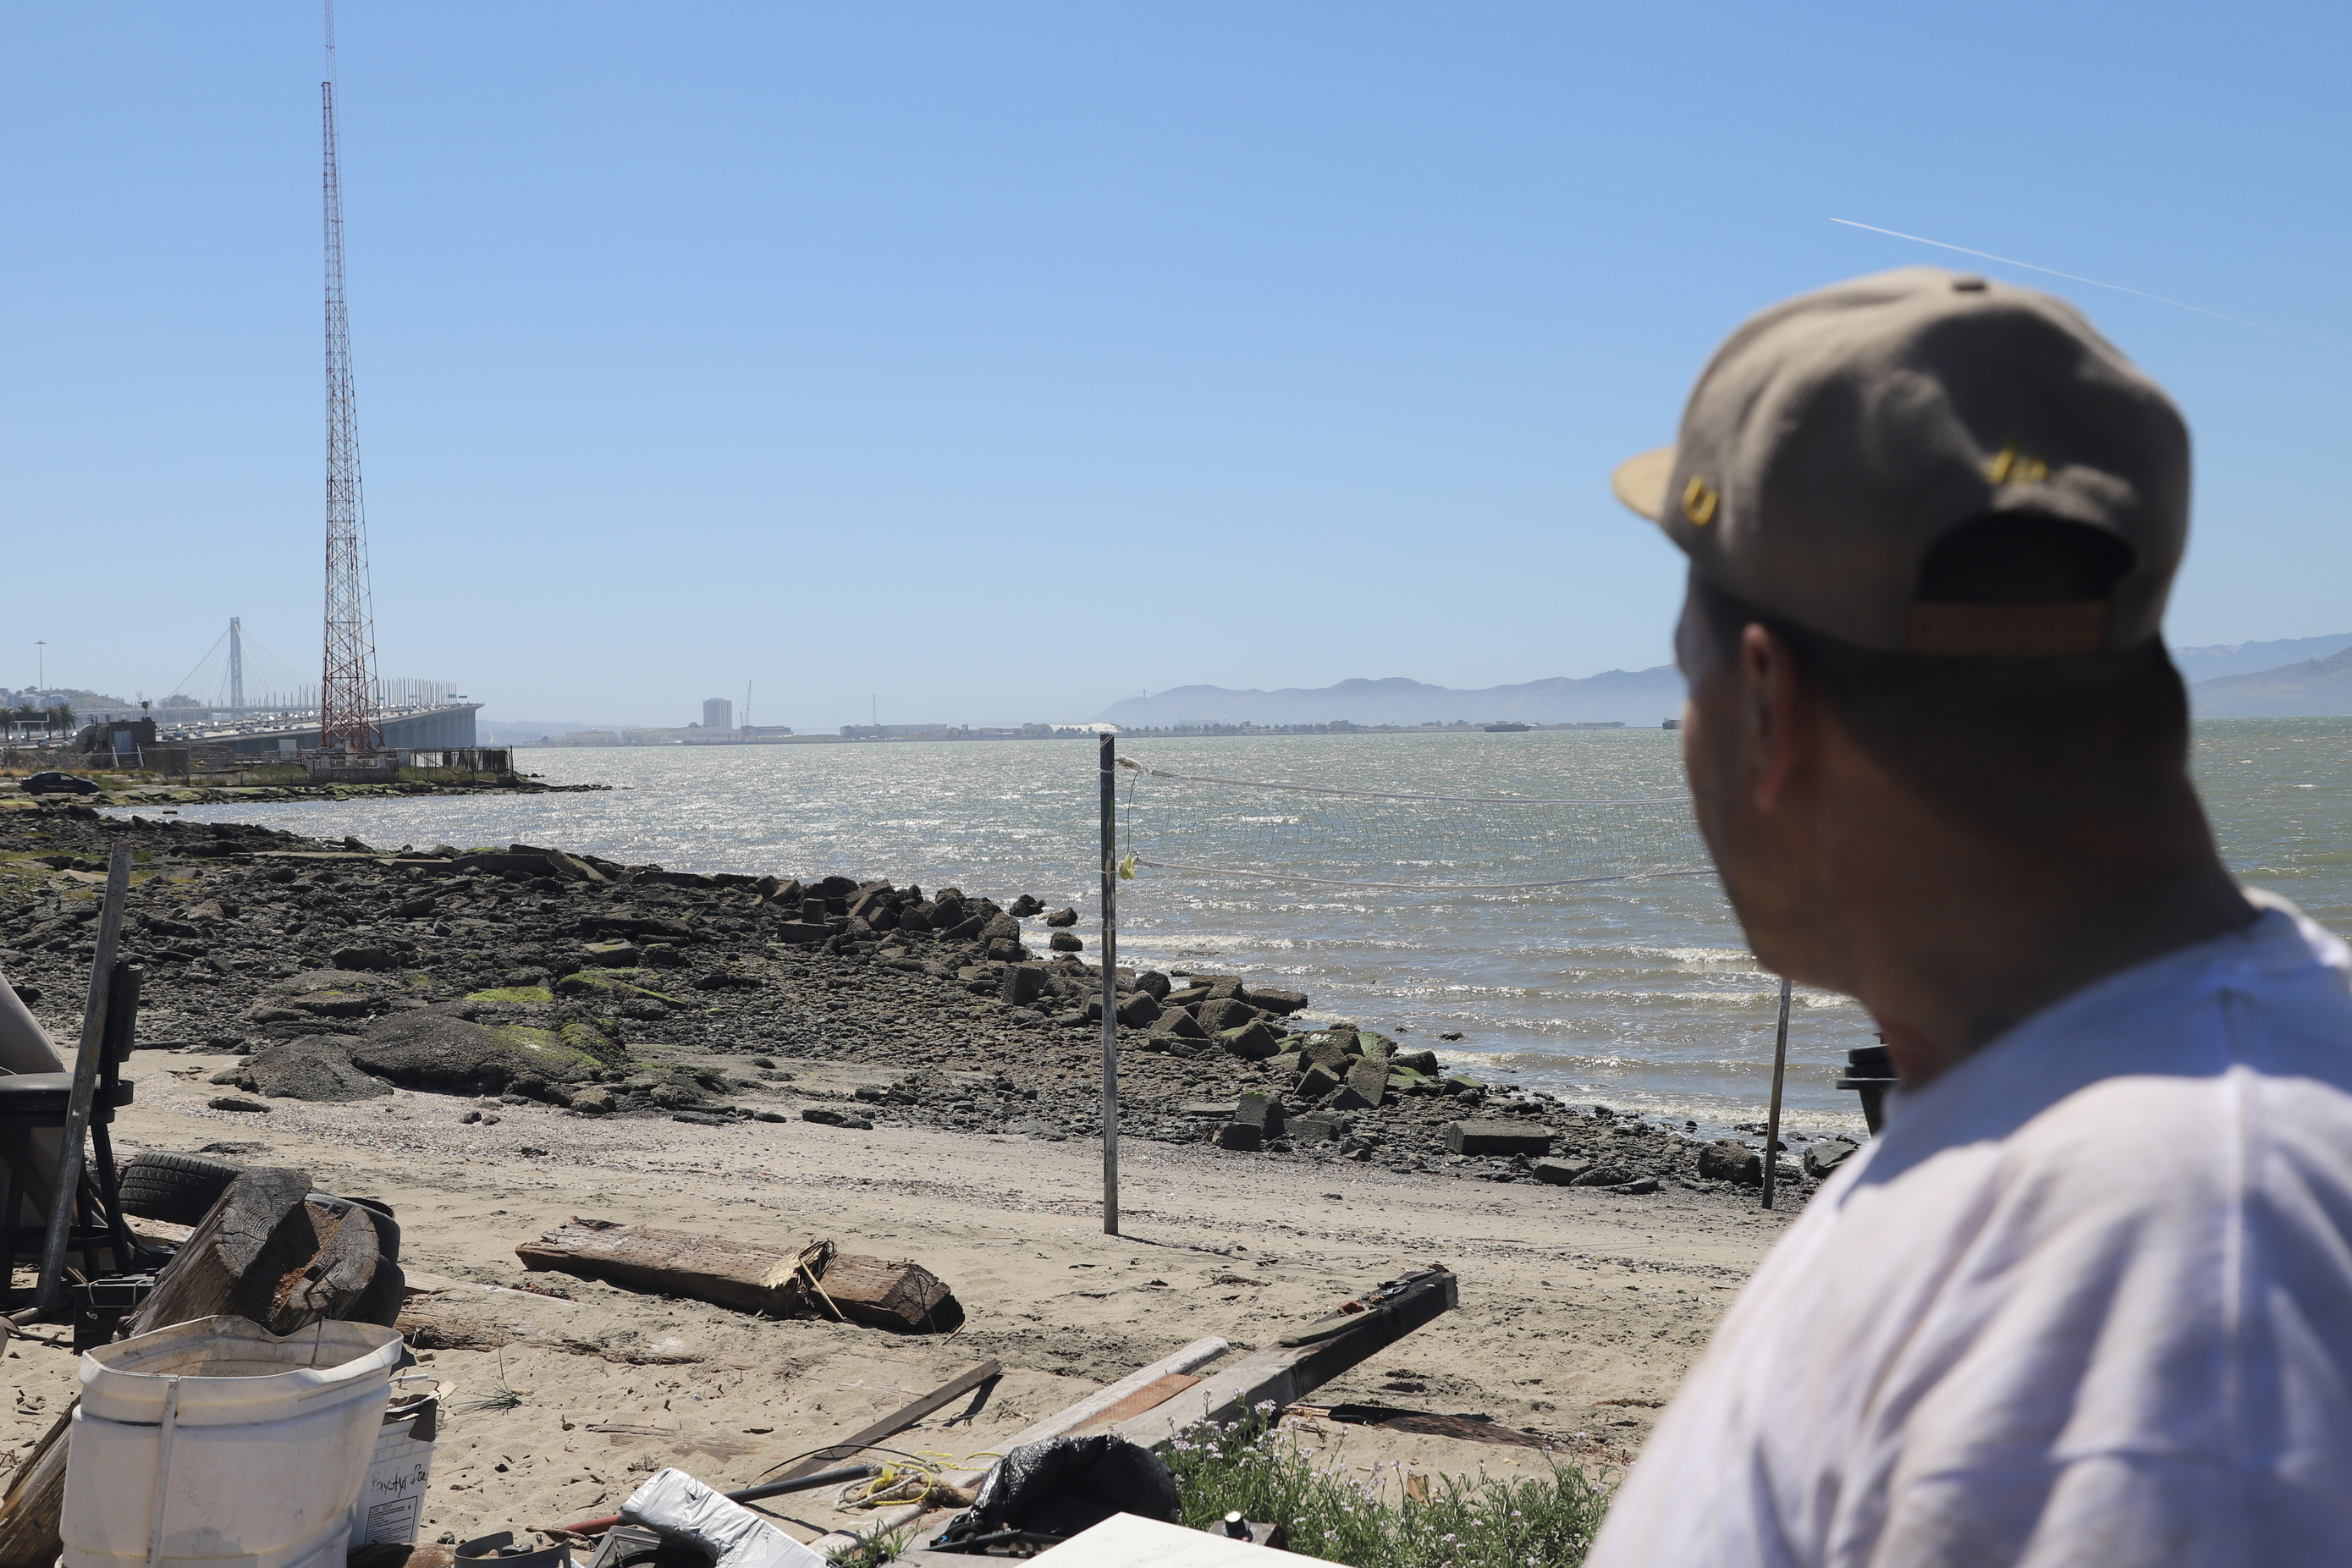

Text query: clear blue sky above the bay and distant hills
(0, 0), (2352, 729)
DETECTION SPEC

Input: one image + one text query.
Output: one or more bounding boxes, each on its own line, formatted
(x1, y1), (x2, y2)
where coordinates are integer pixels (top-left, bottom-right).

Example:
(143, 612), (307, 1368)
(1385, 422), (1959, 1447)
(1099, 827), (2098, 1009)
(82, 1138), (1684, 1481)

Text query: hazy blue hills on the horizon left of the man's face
(1093, 665), (1682, 729)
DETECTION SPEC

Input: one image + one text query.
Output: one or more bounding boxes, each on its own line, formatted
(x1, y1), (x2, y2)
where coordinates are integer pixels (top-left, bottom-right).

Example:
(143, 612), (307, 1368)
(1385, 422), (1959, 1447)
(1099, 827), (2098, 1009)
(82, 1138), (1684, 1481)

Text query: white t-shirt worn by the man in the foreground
(1588, 894), (2352, 1568)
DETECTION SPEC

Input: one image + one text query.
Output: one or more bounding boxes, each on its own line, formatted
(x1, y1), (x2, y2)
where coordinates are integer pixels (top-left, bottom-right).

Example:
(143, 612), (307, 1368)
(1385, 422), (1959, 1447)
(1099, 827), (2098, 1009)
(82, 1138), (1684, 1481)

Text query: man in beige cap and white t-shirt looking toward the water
(1590, 268), (2352, 1568)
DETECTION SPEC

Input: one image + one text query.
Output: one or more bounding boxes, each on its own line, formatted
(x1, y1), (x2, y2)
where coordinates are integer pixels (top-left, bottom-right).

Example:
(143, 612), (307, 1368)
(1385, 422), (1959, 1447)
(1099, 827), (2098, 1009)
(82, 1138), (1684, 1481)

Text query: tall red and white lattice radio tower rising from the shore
(317, 0), (378, 752)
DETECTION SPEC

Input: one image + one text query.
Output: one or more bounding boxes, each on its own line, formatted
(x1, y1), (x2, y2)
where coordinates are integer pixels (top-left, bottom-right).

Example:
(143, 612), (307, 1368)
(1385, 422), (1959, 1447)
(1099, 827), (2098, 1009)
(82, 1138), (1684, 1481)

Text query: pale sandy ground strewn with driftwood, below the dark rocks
(0, 1051), (1782, 1540)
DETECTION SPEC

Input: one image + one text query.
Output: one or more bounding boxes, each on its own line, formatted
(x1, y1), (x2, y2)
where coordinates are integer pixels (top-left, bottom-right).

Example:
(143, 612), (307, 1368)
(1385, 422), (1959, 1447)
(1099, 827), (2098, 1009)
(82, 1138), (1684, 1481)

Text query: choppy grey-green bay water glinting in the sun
(156, 719), (2352, 1133)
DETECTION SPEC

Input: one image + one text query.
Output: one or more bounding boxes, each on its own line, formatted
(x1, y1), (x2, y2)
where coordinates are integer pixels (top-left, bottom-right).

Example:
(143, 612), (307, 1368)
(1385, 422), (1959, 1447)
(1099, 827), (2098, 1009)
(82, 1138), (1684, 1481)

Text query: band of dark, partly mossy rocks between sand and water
(0, 801), (1851, 1206)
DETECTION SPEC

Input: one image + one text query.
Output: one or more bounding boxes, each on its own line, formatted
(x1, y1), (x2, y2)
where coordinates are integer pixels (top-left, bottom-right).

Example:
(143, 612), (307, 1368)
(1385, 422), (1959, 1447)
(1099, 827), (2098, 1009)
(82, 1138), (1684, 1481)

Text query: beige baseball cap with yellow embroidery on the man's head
(1611, 268), (2190, 658)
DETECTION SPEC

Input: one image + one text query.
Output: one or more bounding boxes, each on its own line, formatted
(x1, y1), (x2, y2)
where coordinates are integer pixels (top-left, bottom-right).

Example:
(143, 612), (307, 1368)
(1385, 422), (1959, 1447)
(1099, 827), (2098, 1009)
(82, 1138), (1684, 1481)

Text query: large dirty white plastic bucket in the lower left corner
(58, 1317), (399, 1568)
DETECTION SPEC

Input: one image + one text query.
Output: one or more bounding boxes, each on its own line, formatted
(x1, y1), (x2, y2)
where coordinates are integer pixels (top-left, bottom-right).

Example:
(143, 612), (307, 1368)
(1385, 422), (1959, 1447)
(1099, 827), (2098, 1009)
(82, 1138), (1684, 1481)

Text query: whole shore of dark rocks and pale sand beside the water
(0, 806), (1811, 1540)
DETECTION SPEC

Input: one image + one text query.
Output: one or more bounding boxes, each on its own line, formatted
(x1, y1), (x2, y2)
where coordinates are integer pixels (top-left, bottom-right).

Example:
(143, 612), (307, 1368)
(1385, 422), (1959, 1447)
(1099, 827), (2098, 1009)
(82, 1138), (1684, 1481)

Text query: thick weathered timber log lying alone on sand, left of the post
(515, 1215), (962, 1330)
